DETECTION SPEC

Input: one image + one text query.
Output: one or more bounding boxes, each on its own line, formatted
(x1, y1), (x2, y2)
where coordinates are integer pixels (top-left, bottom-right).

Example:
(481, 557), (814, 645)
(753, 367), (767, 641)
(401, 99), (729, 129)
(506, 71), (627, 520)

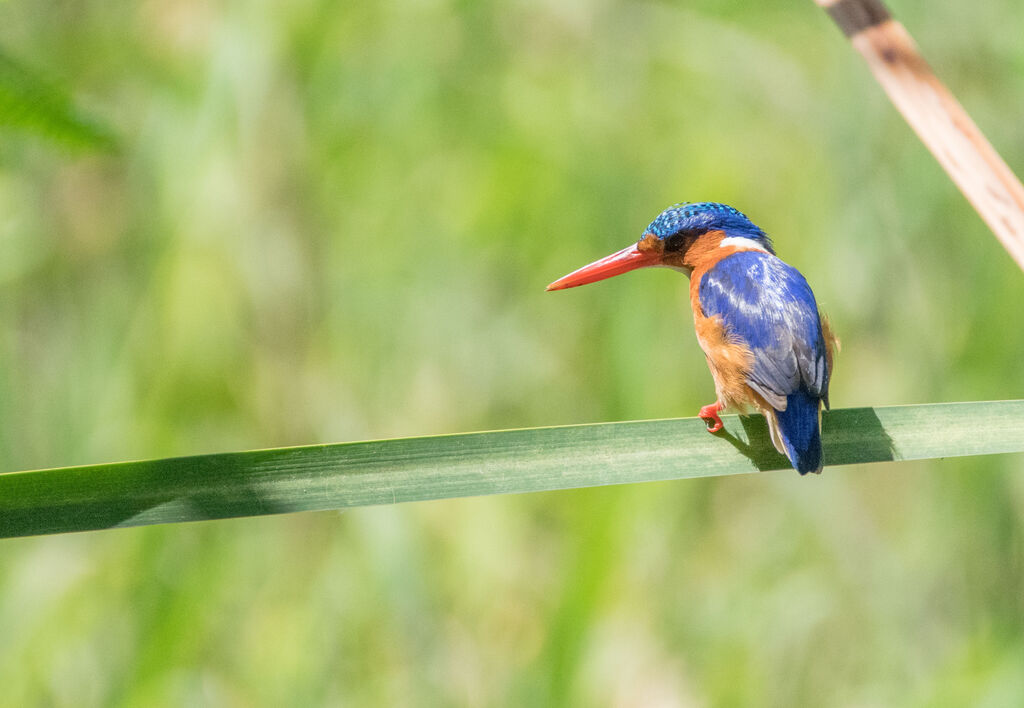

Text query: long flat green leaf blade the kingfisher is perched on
(0, 401), (1024, 538)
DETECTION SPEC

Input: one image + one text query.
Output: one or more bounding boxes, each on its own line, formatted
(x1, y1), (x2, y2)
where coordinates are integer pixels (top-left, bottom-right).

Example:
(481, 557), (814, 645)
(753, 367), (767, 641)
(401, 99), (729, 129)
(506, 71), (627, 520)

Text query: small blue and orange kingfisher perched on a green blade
(548, 202), (838, 474)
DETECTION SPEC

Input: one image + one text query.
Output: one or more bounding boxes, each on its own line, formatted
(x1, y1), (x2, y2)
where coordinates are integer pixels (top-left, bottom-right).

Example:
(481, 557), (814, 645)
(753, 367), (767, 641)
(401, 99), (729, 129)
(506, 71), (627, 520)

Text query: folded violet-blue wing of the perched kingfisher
(698, 251), (829, 411)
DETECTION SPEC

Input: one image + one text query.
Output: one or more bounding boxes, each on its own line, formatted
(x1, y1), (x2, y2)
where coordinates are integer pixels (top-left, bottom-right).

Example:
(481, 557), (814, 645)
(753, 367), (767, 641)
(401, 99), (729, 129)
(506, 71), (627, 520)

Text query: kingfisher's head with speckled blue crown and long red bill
(548, 202), (774, 290)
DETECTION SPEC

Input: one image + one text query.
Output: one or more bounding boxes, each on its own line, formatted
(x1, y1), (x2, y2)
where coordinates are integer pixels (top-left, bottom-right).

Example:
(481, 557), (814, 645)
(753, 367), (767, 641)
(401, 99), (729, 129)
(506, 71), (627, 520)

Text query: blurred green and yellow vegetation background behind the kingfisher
(0, 0), (1024, 706)
